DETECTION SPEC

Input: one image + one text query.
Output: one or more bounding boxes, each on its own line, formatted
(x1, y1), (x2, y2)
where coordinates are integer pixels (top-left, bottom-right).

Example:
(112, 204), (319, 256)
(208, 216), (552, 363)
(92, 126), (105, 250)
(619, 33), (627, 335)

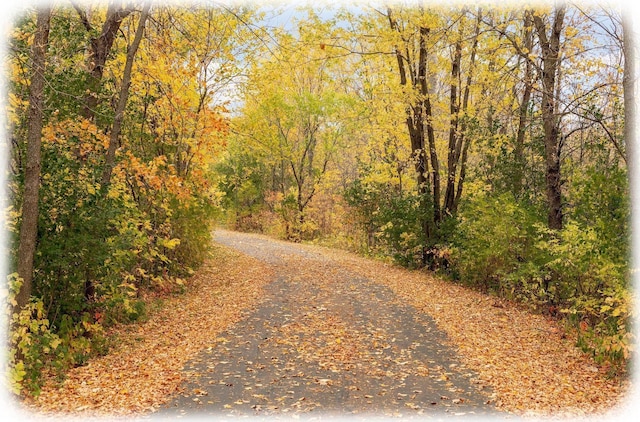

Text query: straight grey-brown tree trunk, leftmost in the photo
(16, 7), (51, 310)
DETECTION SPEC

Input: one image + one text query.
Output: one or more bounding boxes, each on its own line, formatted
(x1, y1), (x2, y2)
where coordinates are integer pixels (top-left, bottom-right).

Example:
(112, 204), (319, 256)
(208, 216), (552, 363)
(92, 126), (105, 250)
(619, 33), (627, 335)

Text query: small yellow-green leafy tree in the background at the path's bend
(234, 22), (353, 240)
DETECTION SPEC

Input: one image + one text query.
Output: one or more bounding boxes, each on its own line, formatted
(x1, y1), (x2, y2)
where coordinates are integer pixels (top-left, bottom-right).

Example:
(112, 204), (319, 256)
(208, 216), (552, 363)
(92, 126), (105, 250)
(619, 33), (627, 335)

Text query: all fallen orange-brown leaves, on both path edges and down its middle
(18, 231), (630, 417)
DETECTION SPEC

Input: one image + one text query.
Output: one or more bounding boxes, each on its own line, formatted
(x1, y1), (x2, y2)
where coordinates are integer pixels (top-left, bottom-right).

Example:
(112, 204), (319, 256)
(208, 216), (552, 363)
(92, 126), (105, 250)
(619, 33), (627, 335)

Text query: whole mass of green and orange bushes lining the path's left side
(9, 118), (222, 394)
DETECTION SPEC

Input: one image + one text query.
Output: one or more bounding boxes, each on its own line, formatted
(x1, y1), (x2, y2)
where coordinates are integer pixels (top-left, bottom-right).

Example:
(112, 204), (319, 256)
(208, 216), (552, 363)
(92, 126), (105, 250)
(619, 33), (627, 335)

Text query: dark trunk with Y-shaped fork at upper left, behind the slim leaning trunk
(72, 2), (133, 120)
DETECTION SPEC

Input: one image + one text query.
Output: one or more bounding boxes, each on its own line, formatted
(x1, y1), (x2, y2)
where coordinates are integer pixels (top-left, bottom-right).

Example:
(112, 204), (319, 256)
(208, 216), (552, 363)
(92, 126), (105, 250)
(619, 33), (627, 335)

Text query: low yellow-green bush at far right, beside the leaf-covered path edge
(537, 221), (633, 366)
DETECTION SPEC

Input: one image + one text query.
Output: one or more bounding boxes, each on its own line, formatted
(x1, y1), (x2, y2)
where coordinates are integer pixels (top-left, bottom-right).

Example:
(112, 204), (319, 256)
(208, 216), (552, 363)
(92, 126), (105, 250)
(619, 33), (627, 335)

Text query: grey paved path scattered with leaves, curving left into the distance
(156, 231), (497, 418)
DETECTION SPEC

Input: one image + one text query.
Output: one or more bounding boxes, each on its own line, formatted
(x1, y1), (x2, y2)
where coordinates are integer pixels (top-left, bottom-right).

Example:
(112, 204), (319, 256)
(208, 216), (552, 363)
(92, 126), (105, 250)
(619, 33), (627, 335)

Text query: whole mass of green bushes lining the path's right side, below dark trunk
(452, 188), (633, 371)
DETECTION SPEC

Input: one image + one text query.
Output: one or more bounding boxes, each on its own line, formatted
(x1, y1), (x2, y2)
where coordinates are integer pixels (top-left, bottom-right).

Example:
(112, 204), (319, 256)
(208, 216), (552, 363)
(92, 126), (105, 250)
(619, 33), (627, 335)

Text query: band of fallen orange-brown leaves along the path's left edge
(20, 246), (273, 417)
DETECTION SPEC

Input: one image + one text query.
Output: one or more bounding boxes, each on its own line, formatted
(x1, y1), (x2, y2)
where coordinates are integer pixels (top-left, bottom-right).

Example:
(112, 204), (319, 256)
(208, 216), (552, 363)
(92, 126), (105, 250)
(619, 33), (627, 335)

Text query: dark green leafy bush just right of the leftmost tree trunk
(34, 121), (145, 326)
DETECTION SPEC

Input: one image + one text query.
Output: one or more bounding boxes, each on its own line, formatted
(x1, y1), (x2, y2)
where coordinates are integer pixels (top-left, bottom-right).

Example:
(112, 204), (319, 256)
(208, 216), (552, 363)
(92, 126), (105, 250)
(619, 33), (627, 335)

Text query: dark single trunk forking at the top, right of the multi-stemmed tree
(533, 4), (566, 230)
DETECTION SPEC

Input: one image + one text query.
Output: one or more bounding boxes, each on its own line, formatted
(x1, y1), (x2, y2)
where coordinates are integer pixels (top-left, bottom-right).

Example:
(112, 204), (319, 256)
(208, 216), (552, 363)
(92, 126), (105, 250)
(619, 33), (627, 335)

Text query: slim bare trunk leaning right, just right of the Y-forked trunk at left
(102, 3), (151, 187)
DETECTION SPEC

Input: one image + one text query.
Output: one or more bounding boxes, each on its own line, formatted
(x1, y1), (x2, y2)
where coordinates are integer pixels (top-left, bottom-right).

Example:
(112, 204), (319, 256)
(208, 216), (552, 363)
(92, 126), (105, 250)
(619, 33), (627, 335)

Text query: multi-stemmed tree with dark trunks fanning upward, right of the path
(386, 4), (482, 254)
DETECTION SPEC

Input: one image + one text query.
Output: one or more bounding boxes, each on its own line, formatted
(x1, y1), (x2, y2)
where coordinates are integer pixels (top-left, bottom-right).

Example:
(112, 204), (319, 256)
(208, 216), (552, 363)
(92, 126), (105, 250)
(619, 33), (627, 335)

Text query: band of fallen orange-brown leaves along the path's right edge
(325, 249), (630, 416)
